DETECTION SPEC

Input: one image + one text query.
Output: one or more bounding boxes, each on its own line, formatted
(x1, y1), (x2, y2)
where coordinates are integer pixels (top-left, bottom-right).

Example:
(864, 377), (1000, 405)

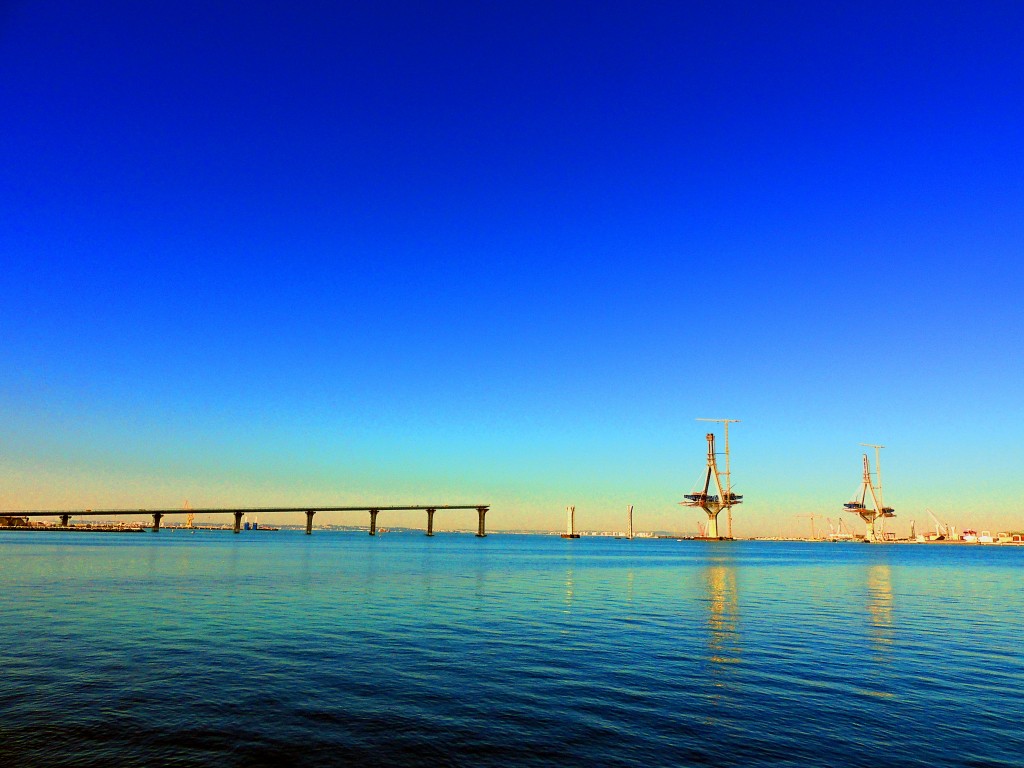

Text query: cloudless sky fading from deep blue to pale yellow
(0, 1), (1024, 536)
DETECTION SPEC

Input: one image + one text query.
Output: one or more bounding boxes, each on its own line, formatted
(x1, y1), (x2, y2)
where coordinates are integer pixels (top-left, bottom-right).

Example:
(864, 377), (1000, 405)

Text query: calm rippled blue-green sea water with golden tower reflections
(0, 530), (1024, 767)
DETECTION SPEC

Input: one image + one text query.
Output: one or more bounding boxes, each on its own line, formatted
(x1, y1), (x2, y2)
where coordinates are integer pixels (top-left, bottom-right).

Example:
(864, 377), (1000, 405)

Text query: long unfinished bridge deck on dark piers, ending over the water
(6, 504), (490, 538)
